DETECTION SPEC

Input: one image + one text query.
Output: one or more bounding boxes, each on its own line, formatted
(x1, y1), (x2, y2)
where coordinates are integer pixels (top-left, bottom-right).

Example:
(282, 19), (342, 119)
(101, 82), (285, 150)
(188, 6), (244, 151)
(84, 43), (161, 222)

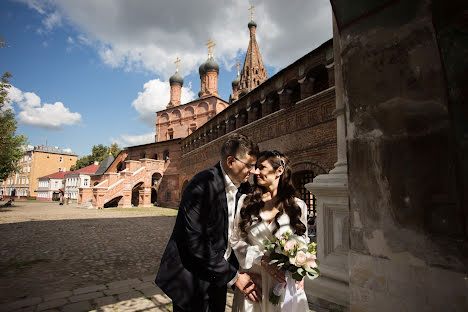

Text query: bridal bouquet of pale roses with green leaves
(263, 232), (320, 305)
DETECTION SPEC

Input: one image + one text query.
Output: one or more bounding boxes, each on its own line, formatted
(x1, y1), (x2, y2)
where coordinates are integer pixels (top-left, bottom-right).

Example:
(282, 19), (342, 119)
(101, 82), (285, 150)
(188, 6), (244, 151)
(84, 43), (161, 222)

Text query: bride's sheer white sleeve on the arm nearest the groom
(230, 196), (264, 270)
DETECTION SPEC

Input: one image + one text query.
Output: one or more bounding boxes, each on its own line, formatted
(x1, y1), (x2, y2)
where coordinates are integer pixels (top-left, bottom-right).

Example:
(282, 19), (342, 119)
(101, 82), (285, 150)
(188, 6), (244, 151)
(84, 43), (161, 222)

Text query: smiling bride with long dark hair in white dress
(231, 151), (309, 312)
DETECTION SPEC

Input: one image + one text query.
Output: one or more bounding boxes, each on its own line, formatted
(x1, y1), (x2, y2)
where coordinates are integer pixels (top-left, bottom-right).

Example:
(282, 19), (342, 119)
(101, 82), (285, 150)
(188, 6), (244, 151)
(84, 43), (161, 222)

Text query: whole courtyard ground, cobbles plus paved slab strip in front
(0, 201), (325, 312)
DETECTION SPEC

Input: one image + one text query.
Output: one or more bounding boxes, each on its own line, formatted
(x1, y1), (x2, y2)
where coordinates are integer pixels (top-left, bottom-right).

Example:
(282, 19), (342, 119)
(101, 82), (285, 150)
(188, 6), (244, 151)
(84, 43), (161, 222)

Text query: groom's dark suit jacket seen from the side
(155, 163), (246, 311)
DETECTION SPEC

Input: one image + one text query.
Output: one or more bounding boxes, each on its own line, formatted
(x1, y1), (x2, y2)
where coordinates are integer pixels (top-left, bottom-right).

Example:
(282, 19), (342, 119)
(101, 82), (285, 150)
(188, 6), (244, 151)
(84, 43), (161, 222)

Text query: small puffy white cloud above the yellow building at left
(8, 86), (81, 129)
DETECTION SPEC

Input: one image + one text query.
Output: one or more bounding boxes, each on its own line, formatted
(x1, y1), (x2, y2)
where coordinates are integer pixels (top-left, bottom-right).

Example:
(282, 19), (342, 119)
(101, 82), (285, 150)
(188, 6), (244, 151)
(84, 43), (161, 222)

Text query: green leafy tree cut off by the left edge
(0, 72), (28, 180)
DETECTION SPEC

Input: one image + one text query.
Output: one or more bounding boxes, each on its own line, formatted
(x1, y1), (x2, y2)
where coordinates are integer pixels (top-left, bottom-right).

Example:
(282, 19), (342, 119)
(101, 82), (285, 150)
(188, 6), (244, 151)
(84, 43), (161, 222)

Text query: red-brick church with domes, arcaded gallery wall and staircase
(79, 15), (336, 213)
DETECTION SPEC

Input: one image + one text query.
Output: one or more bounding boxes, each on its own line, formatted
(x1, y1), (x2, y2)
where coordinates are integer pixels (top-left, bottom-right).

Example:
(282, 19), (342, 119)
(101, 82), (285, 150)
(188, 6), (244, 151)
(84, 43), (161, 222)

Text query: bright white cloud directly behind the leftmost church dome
(132, 79), (195, 127)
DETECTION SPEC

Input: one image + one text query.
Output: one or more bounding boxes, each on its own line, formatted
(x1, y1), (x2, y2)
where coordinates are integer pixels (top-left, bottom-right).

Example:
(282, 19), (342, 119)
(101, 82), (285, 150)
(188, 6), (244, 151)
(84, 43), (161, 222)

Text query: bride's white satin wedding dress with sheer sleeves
(230, 195), (309, 312)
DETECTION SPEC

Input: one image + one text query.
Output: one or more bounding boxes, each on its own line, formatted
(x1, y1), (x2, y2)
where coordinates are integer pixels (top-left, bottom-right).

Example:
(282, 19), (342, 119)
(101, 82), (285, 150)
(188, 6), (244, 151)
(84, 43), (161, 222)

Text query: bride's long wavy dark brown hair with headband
(239, 151), (306, 237)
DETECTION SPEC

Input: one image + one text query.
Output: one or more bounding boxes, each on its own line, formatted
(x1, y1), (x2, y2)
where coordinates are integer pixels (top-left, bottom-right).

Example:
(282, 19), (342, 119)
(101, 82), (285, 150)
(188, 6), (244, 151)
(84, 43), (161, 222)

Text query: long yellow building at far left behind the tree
(0, 145), (78, 197)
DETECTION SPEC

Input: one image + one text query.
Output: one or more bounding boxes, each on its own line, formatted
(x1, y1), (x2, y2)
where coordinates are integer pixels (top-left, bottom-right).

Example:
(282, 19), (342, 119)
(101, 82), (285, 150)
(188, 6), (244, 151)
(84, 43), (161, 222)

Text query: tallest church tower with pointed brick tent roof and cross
(239, 6), (268, 96)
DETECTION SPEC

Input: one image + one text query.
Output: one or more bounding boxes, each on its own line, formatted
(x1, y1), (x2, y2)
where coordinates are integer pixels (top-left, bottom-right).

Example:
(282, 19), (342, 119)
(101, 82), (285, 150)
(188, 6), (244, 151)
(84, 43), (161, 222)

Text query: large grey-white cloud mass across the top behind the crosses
(17, 0), (332, 79)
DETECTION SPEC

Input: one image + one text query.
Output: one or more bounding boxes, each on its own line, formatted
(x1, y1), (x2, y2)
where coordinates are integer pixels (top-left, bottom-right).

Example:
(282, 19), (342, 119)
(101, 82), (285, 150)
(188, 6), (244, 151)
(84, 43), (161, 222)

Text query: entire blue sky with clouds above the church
(0, 0), (332, 156)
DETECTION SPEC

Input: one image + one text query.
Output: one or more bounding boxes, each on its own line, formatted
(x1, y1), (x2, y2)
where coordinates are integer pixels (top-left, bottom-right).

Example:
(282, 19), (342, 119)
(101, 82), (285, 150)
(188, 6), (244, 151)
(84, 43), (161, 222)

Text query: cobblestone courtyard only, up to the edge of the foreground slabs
(0, 201), (177, 303)
